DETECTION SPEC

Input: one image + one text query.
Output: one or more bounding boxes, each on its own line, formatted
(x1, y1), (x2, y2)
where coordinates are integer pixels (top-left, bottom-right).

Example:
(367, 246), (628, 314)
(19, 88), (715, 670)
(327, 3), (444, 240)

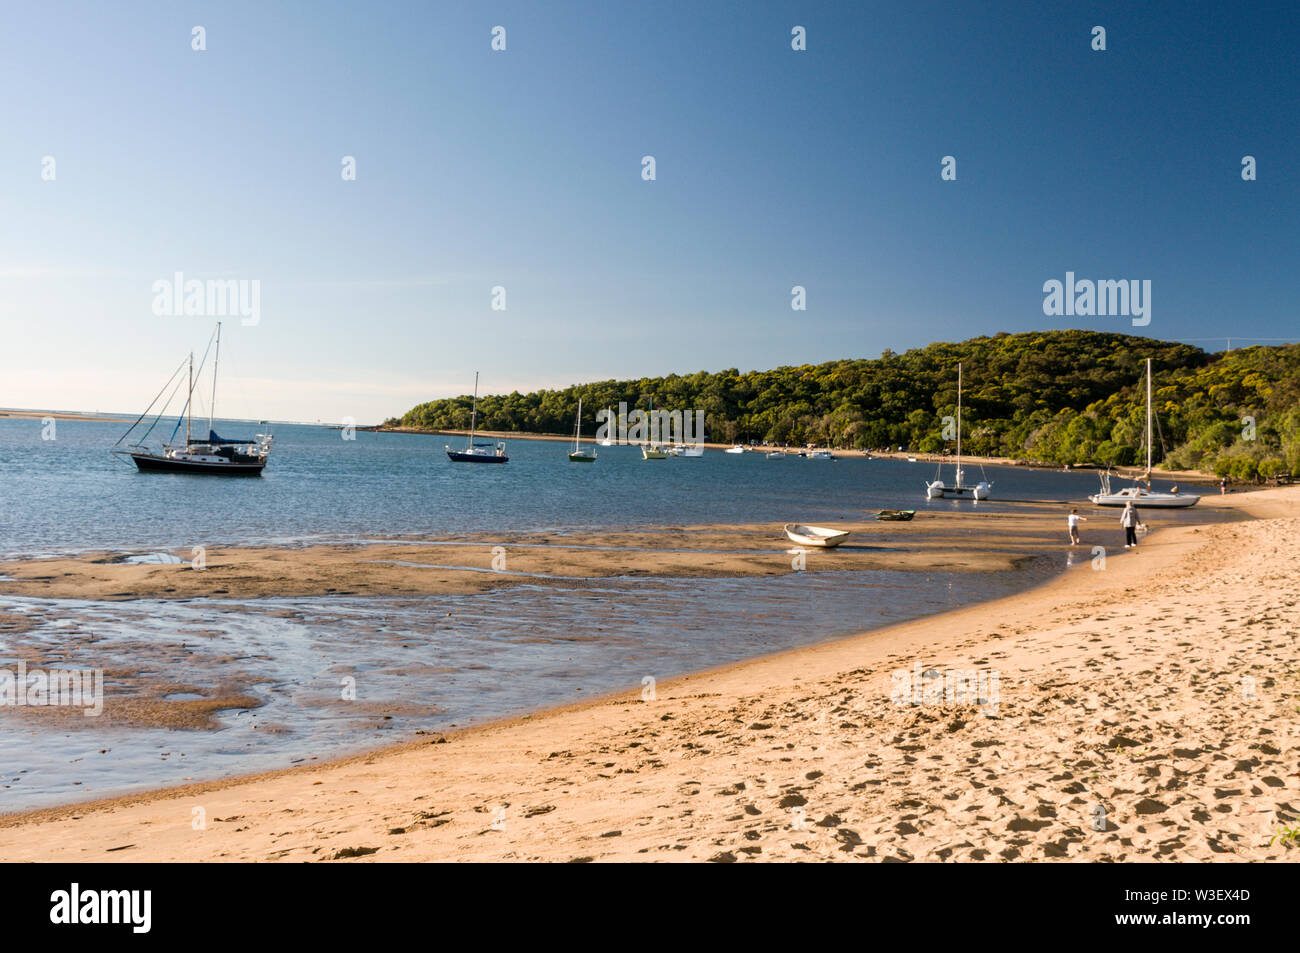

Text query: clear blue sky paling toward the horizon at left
(0, 1), (1300, 423)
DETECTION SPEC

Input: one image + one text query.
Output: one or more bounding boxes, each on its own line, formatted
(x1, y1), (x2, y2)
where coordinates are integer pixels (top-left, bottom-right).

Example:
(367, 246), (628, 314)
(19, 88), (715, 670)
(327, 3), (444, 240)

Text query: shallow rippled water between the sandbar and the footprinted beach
(0, 559), (1060, 810)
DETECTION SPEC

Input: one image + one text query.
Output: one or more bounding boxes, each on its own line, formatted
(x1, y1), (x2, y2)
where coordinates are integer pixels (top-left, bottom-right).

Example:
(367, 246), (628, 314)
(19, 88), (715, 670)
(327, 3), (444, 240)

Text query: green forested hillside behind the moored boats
(386, 330), (1300, 480)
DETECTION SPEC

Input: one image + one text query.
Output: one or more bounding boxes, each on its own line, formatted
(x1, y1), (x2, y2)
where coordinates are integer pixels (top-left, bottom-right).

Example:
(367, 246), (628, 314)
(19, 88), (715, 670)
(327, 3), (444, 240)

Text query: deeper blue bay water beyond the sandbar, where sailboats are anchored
(0, 419), (1201, 556)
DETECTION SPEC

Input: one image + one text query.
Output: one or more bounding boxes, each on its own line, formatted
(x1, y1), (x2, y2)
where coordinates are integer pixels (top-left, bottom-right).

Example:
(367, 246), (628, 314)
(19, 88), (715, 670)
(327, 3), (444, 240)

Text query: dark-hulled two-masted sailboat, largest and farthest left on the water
(113, 321), (272, 476)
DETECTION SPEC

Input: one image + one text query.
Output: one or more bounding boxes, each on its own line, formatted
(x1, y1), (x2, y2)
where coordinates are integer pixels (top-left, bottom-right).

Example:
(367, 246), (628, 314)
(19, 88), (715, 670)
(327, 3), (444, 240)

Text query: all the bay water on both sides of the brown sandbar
(0, 419), (1212, 811)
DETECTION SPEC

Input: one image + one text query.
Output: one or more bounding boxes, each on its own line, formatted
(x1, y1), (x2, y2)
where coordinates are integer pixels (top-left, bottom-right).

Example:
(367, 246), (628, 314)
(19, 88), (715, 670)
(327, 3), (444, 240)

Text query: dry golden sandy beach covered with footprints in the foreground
(0, 488), (1300, 862)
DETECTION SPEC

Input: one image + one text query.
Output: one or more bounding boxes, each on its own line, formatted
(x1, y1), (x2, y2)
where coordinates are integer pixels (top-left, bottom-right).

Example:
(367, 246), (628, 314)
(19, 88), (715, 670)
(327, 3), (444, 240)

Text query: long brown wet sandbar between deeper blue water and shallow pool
(0, 506), (1076, 599)
